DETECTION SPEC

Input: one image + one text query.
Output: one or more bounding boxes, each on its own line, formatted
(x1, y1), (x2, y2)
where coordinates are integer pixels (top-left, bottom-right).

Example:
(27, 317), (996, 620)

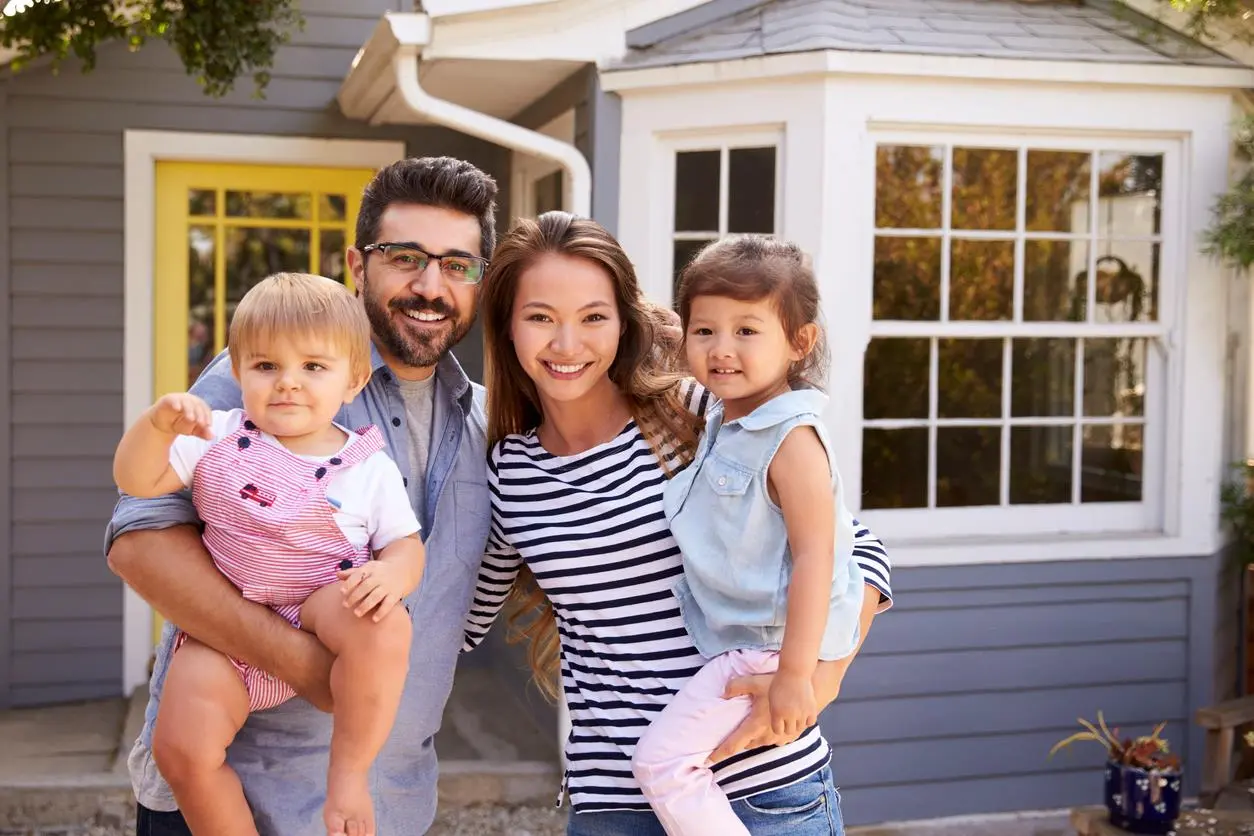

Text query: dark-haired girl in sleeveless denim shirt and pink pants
(632, 236), (864, 836)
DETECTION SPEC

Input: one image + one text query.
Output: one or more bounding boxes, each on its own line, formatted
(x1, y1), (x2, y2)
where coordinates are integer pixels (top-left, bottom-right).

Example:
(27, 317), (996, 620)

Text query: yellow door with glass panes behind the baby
(153, 163), (374, 642)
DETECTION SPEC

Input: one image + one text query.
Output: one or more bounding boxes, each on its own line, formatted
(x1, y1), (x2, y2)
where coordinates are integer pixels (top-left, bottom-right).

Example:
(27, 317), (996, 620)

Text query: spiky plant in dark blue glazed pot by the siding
(1050, 712), (1181, 835)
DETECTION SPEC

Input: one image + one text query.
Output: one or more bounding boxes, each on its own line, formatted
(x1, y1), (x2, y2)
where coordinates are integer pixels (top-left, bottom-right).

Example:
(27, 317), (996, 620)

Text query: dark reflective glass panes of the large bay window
(863, 144), (1165, 508)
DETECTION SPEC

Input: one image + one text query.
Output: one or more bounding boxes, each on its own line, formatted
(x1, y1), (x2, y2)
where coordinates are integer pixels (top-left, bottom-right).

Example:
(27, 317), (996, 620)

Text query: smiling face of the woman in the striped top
(509, 253), (622, 413)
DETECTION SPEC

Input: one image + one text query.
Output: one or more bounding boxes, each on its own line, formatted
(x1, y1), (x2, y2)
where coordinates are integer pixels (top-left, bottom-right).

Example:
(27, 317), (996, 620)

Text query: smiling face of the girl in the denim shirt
(685, 296), (816, 421)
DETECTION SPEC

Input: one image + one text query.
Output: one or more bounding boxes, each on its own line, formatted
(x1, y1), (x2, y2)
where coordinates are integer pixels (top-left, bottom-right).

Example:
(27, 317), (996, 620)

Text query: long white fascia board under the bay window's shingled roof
(601, 50), (1254, 93)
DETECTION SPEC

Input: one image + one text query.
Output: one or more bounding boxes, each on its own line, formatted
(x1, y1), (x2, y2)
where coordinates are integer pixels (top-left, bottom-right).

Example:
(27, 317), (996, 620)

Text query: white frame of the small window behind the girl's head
(650, 128), (785, 305)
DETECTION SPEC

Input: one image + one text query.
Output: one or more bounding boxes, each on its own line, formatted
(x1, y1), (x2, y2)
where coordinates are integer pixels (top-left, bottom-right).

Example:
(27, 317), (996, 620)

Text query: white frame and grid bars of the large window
(852, 128), (1188, 543)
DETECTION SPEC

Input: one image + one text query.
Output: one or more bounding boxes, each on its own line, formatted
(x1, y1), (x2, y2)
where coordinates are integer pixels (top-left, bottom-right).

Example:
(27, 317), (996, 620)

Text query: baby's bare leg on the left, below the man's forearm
(153, 638), (257, 836)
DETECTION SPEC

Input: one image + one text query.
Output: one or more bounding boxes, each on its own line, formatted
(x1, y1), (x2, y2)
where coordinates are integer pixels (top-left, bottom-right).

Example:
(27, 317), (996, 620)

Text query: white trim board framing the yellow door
(122, 130), (405, 694)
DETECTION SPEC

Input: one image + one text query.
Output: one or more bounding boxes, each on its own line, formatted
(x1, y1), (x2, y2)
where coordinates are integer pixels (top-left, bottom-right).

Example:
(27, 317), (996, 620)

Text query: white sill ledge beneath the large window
(873, 528), (1224, 569)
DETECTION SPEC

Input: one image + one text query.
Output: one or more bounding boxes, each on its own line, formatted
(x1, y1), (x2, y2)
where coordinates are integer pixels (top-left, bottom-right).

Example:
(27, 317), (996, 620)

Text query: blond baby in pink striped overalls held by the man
(114, 273), (424, 836)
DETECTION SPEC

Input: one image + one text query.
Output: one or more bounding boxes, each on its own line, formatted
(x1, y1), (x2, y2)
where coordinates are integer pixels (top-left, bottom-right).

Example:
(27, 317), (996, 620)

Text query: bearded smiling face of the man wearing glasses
(349, 203), (484, 380)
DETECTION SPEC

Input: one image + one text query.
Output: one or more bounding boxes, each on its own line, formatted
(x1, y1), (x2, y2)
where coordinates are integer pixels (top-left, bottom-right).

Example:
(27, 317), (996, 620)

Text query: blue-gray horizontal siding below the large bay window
(823, 558), (1219, 823)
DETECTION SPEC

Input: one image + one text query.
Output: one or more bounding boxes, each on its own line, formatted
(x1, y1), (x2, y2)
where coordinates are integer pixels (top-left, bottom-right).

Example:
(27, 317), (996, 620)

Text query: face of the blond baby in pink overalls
(232, 335), (366, 451)
